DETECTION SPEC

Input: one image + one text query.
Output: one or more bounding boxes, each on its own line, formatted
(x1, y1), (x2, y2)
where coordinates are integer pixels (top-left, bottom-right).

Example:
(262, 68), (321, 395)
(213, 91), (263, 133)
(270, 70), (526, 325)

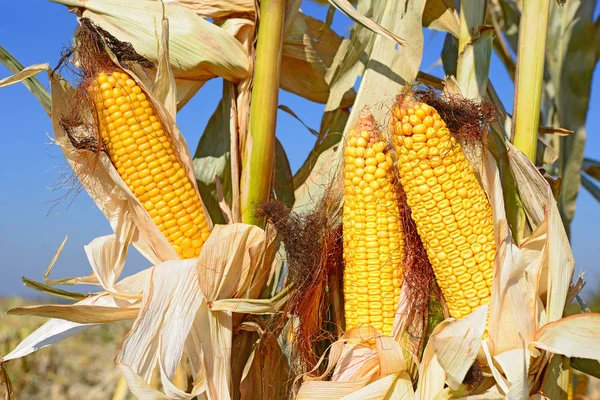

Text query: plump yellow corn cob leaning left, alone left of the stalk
(89, 72), (210, 258)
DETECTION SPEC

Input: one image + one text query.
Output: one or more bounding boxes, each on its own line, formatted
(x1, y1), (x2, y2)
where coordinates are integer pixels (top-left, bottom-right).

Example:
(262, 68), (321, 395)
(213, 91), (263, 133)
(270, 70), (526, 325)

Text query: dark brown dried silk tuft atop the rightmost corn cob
(396, 84), (498, 143)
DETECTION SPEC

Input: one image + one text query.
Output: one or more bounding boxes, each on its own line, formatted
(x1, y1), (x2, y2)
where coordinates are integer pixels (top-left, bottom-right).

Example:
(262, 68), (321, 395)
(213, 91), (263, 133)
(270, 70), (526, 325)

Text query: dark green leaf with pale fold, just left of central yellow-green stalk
(193, 80), (237, 224)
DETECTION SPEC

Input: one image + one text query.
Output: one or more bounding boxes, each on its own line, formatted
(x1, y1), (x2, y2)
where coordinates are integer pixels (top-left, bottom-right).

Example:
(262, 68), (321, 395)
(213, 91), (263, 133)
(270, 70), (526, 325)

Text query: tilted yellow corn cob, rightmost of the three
(390, 102), (496, 318)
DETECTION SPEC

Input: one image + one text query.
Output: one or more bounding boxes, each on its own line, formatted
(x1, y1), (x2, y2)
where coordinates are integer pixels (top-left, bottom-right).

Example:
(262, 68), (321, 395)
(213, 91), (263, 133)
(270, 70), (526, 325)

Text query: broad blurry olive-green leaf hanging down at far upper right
(545, 0), (597, 234)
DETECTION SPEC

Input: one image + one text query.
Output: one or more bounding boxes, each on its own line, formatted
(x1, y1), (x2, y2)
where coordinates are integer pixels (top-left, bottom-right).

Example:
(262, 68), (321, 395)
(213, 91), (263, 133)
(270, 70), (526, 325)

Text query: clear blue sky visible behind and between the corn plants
(0, 0), (600, 296)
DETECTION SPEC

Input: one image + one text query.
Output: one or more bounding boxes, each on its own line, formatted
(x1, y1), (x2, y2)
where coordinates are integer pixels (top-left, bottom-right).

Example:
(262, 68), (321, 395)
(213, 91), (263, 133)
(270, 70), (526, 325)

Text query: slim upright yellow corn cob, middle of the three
(343, 114), (404, 335)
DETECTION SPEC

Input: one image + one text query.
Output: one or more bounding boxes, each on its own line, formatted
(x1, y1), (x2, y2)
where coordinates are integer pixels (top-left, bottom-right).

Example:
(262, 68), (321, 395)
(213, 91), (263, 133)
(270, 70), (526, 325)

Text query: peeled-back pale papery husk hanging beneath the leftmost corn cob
(115, 224), (284, 399)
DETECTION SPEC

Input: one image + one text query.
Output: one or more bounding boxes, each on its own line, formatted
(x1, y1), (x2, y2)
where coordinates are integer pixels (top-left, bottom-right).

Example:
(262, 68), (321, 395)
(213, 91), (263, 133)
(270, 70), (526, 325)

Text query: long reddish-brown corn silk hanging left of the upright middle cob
(258, 202), (343, 376)
